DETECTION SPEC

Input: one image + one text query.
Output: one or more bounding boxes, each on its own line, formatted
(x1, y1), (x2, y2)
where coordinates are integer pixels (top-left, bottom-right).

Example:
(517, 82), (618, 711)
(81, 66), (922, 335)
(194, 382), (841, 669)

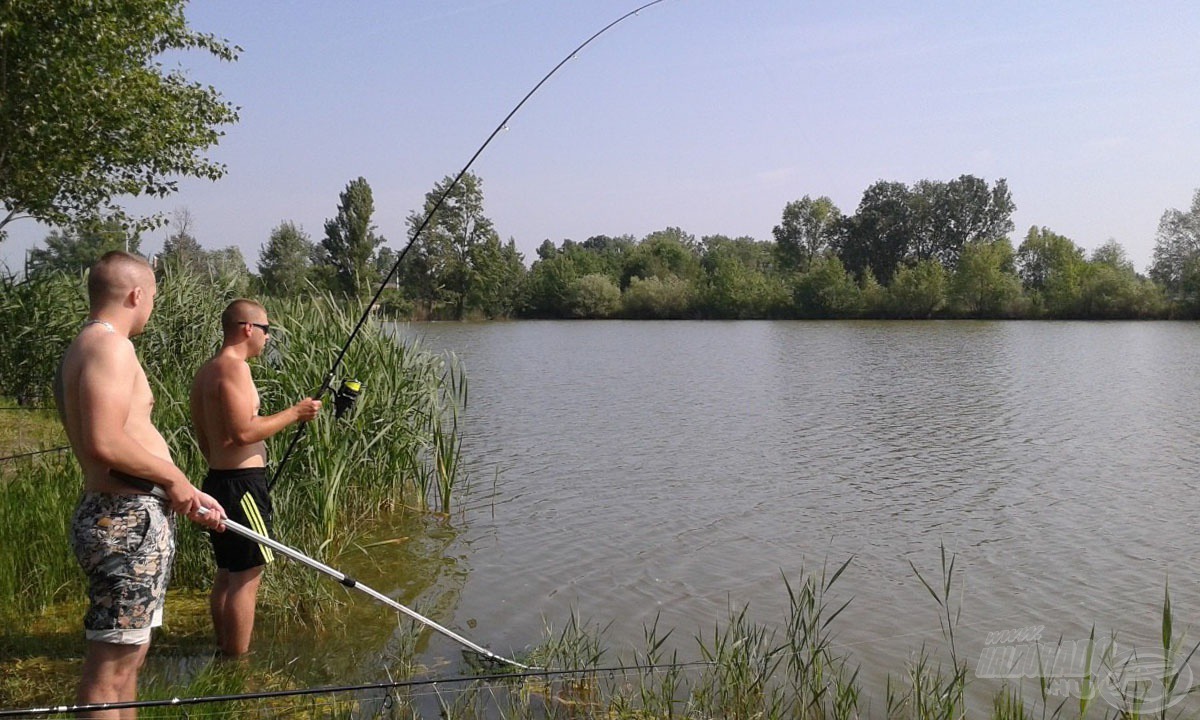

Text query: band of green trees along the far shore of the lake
(9, 173), (1200, 319)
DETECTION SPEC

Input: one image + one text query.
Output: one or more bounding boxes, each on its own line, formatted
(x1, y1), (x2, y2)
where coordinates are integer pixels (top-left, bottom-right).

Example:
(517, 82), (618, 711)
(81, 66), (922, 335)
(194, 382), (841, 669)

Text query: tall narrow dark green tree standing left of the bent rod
(319, 178), (384, 296)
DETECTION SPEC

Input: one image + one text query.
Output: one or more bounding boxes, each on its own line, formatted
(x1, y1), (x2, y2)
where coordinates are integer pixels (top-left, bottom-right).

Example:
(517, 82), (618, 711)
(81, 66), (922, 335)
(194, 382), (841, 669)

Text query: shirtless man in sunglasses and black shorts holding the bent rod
(192, 300), (320, 658)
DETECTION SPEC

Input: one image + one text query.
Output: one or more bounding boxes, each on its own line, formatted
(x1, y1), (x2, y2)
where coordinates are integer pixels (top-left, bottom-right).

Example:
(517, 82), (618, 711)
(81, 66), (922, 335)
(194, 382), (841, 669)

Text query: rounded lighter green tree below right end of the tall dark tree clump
(950, 238), (1021, 318)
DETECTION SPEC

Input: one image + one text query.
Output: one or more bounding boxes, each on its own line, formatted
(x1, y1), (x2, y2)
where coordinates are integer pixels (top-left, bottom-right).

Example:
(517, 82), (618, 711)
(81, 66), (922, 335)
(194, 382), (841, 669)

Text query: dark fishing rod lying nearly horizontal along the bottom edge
(0, 660), (715, 718)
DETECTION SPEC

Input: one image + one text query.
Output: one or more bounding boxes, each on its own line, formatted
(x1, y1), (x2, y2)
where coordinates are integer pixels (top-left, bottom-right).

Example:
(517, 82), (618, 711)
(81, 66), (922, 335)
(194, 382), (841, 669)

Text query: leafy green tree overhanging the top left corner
(0, 0), (238, 238)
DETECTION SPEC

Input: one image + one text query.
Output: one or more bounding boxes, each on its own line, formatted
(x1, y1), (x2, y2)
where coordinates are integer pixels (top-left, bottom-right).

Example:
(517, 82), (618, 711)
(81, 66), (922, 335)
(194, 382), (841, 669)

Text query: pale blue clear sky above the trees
(0, 0), (1200, 271)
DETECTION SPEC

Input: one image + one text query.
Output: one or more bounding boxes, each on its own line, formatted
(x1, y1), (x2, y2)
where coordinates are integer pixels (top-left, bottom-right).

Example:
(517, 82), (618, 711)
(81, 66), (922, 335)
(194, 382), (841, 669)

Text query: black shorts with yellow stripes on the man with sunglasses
(202, 468), (275, 572)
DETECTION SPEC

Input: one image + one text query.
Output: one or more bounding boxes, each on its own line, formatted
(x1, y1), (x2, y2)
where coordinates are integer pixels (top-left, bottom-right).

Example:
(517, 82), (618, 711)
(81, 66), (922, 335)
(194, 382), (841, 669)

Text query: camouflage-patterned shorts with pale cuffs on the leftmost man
(71, 492), (175, 644)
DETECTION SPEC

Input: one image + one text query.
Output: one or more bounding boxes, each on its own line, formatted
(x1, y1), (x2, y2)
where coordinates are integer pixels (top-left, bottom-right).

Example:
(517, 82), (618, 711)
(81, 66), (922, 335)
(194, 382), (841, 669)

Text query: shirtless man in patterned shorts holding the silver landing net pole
(54, 251), (224, 718)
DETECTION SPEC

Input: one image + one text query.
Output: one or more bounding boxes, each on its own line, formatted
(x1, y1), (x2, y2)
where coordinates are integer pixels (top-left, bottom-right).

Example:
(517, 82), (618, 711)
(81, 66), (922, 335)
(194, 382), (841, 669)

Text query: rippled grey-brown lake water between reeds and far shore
(393, 322), (1200, 714)
